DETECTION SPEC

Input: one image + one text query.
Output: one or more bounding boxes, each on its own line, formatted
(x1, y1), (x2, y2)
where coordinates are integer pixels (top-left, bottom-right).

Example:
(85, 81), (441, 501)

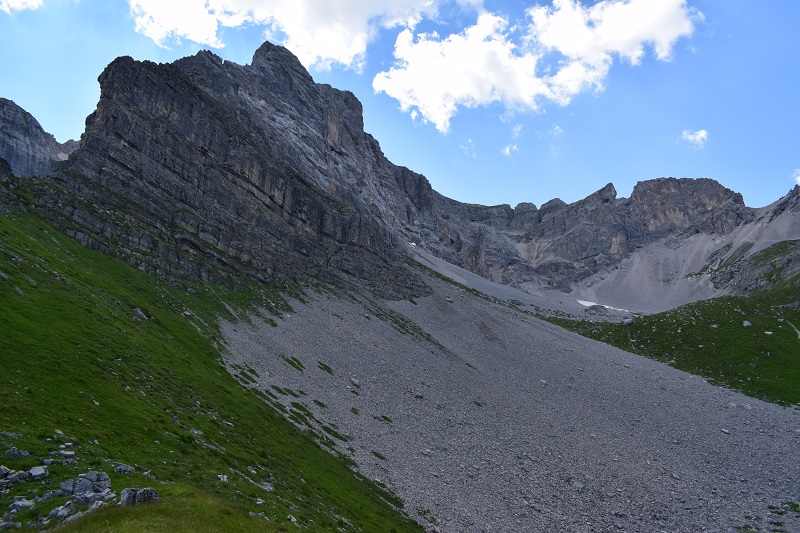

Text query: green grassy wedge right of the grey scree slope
(547, 254), (800, 405)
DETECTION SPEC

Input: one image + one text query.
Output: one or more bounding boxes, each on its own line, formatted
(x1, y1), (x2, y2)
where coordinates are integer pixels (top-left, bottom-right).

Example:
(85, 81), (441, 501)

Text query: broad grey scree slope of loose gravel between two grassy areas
(222, 272), (800, 532)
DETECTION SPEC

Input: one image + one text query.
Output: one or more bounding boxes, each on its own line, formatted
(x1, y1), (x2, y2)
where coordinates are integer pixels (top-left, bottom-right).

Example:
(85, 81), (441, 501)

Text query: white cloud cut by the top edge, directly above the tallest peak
(129, 0), (439, 68)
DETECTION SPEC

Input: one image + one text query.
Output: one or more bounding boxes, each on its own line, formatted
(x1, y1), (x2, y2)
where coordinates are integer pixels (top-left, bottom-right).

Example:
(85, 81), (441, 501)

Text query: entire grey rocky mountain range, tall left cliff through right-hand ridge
(0, 43), (800, 310)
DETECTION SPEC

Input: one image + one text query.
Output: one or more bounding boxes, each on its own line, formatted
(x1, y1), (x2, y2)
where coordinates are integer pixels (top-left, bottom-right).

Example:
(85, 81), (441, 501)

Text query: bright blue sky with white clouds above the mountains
(0, 0), (800, 207)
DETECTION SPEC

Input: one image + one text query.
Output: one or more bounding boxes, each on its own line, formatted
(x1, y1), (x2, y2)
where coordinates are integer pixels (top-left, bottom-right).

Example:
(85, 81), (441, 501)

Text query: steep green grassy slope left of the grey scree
(0, 209), (420, 531)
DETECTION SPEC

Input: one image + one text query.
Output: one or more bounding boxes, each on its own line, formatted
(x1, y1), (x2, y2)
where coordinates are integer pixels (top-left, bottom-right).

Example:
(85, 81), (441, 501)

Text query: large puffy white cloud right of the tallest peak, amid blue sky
(373, 0), (702, 132)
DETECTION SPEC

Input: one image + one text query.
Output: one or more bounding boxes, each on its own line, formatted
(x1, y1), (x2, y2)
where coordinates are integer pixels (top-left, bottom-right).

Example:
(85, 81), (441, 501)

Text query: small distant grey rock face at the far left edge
(0, 98), (78, 176)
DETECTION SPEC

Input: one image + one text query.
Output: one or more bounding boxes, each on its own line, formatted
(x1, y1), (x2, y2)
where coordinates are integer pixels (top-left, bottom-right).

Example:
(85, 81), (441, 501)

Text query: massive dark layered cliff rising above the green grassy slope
(32, 45), (426, 295)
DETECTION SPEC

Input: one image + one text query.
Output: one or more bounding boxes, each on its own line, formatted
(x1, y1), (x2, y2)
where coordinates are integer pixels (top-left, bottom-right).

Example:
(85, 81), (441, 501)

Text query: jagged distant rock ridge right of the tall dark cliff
(406, 178), (755, 291)
